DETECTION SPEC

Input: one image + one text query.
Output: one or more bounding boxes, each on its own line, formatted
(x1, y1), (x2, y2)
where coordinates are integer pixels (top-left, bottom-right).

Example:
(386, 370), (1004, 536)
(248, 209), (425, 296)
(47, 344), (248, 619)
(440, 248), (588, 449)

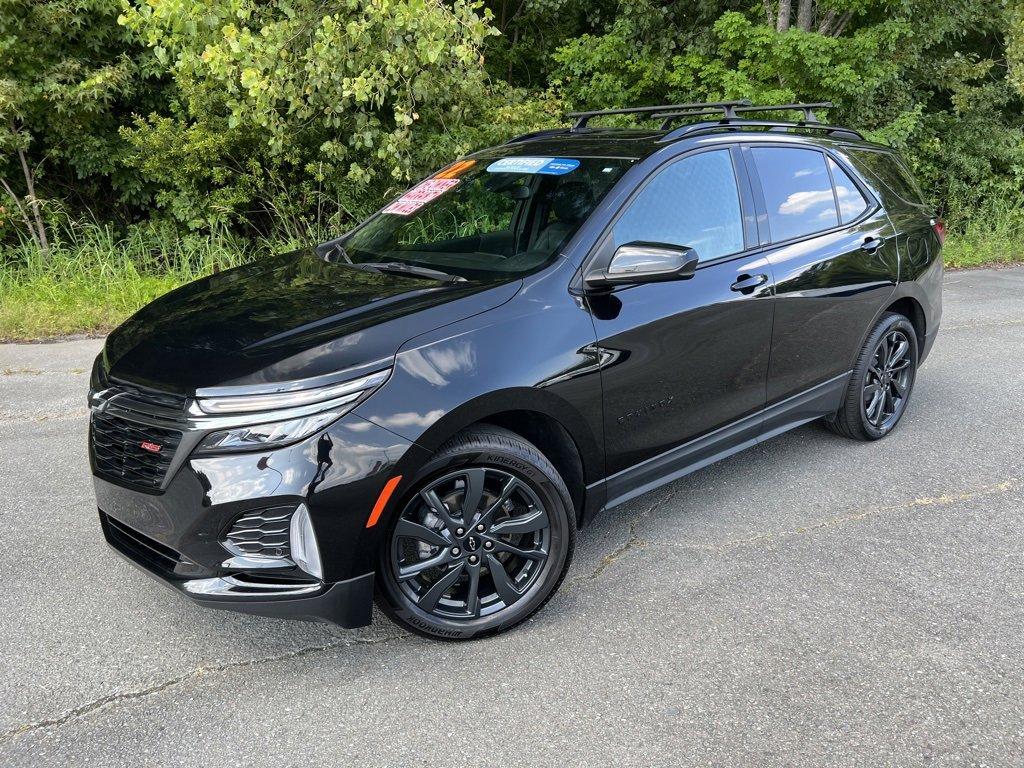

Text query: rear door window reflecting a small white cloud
(752, 146), (839, 242)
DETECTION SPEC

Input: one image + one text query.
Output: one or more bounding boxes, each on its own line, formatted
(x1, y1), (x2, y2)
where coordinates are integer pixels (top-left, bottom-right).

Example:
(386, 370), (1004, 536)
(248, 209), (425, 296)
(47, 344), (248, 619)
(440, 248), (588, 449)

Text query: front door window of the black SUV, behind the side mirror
(612, 150), (743, 260)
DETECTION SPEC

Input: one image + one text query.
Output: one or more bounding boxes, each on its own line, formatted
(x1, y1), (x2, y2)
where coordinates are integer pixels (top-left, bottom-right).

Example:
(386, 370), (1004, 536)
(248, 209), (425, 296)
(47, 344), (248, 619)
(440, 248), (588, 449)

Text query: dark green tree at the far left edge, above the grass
(0, 0), (156, 259)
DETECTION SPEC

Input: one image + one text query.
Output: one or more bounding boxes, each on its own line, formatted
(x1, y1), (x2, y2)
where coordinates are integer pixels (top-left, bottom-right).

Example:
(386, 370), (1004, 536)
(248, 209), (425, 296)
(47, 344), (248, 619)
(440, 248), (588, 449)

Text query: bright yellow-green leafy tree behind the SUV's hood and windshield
(122, 0), (492, 234)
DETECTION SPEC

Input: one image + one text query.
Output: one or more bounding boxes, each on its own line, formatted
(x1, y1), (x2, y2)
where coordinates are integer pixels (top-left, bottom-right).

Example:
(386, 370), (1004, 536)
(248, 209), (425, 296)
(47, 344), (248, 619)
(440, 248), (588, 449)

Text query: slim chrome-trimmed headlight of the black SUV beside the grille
(191, 371), (391, 454)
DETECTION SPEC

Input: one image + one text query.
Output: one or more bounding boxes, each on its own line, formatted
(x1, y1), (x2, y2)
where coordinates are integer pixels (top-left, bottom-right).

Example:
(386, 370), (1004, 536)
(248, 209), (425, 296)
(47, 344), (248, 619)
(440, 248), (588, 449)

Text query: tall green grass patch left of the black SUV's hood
(0, 224), (271, 339)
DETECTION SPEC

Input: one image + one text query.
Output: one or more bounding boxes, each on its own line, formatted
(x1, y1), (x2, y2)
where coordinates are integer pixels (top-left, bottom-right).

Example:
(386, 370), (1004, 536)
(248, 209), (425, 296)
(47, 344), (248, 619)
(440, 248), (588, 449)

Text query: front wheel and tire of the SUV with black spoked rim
(377, 426), (575, 640)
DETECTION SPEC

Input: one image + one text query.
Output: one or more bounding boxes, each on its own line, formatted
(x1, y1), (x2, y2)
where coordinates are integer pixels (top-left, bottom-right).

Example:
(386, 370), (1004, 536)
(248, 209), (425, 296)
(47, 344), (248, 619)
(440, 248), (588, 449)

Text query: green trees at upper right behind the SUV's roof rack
(552, 0), (1024, 218)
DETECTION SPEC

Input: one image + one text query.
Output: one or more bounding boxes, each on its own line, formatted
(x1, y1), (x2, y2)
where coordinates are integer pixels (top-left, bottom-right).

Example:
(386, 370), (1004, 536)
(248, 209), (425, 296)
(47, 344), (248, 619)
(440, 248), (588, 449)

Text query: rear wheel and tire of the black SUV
(824, 312), (919, 440)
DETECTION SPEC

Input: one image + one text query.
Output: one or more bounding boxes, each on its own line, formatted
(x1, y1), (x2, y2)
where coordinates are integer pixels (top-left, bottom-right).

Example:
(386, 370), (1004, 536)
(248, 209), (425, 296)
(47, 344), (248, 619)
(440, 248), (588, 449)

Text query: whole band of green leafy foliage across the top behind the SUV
(0, 0), (1024, 249)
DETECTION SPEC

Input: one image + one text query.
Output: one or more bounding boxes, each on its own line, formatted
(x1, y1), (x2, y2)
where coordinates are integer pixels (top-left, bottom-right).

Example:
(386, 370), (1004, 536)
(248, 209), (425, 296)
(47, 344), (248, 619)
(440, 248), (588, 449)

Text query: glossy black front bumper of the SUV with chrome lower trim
(93, 414), (425, 628)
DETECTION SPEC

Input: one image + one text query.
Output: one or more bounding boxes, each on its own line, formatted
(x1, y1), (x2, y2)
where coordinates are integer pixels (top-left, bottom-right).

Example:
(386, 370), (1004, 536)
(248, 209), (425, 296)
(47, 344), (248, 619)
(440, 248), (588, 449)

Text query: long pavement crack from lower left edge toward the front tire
(0, 632), (411, 746)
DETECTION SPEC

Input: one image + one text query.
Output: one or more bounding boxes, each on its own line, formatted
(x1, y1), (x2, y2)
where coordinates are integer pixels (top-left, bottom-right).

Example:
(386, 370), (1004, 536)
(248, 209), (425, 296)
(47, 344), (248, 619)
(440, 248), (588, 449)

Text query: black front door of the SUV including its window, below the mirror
(587, 148), (774, 503)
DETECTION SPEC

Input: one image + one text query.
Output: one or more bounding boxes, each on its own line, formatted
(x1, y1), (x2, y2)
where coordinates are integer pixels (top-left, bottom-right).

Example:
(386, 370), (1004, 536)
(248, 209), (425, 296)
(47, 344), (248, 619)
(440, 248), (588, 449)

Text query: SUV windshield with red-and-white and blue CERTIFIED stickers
(337, 157), (633, 280)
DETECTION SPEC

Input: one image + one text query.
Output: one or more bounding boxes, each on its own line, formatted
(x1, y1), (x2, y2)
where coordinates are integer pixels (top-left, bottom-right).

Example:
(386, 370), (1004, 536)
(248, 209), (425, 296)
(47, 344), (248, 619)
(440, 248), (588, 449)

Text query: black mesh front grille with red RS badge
(92, 413), (181, 490)
